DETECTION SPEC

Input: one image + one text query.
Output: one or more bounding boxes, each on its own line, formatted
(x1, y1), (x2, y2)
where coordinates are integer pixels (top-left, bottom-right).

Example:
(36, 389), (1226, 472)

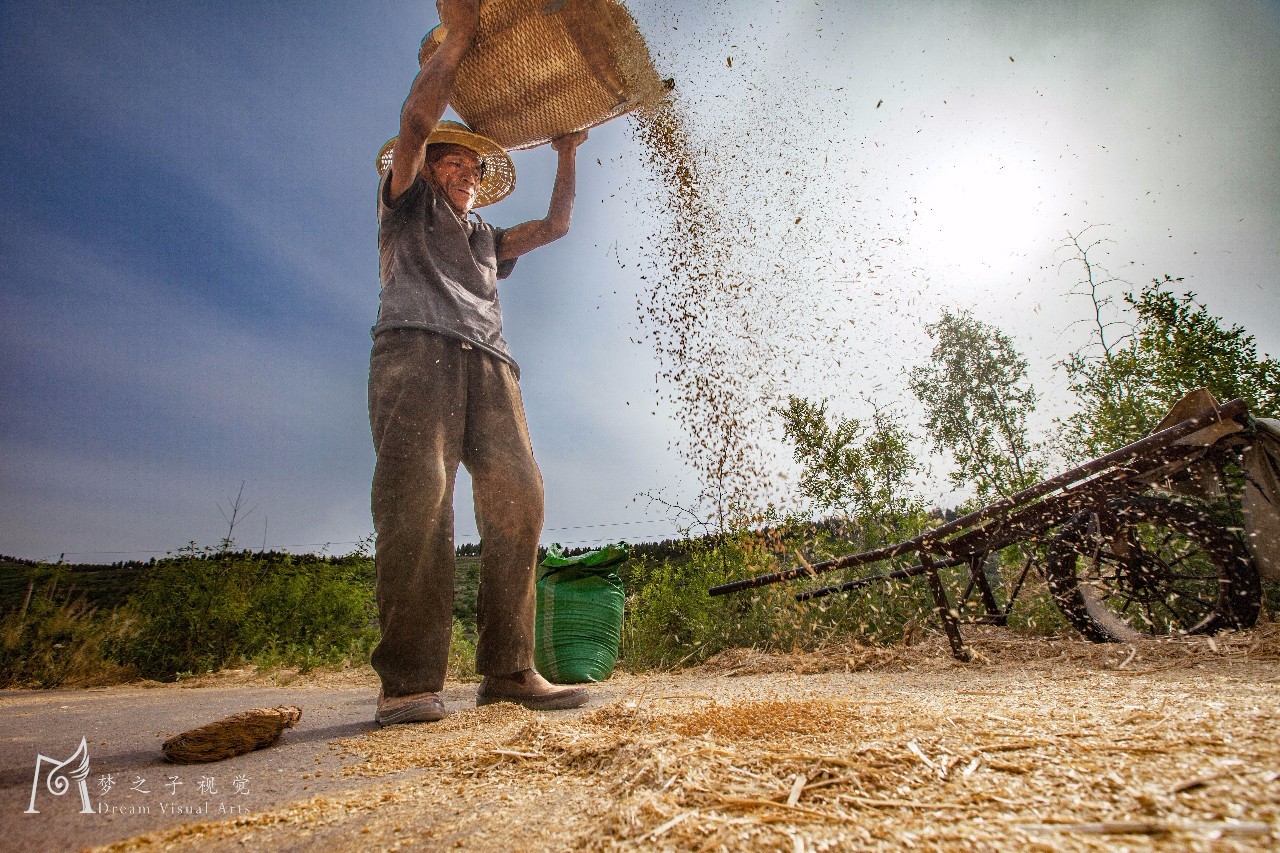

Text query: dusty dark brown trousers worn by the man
(369, 329), (543, 697)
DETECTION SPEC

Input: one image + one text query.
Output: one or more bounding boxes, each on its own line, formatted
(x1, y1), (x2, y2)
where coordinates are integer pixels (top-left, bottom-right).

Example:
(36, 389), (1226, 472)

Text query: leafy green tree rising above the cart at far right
(1062, 275), (1280, 460)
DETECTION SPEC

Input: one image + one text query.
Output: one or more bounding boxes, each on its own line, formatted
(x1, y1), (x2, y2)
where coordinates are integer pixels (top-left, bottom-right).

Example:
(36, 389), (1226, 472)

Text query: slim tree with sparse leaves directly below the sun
(909, 311), (1042, 501)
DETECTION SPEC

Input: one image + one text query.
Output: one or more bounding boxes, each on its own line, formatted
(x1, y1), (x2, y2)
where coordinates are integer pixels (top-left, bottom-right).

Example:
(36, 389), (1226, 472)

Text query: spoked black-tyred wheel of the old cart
(1044, 494), (1262, 643)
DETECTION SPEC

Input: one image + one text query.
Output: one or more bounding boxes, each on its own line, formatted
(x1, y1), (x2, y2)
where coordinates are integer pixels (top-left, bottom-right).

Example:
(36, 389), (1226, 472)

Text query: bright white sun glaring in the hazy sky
(915, 143), (1057, 273)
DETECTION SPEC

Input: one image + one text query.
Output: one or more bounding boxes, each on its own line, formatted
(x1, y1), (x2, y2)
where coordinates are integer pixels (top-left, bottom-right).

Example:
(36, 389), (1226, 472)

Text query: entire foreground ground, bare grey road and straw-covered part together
(0, 625), (1280, 850)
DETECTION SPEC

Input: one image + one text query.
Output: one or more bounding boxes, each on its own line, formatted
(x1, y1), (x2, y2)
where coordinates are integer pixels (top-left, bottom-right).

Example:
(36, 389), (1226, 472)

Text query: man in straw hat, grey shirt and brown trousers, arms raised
(369, 0), (588, 725)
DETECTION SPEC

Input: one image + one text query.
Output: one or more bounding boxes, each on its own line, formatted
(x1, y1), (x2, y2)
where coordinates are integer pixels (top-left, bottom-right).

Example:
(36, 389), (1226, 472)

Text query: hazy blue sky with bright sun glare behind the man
(0, 0), (1280, 562)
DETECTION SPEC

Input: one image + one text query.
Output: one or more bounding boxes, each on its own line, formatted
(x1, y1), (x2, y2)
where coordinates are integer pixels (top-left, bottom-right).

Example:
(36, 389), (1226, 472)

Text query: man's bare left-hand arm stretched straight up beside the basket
(390, 0), (480, 199)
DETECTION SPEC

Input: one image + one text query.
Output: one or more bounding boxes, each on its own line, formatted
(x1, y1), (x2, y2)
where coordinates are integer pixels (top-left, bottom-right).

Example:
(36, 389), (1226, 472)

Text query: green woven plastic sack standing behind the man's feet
(534, 543), (630, 684)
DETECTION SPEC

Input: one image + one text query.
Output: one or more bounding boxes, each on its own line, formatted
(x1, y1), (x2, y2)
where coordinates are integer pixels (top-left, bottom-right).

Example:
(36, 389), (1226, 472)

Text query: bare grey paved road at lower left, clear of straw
(0, 684), (445, 850)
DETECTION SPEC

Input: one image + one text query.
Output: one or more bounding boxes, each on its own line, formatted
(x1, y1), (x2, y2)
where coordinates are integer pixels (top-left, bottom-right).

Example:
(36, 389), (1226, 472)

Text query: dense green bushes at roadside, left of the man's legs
(122, 553), (376, 678)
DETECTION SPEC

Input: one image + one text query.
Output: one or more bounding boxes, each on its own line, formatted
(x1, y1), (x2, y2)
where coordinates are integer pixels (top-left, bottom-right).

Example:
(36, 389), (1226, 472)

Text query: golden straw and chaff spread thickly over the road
(97, 625), (1280, 850)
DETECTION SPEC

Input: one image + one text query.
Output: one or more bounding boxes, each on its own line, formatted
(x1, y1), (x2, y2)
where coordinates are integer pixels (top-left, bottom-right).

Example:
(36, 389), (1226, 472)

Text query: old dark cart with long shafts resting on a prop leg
(709, 391), (1262, 661)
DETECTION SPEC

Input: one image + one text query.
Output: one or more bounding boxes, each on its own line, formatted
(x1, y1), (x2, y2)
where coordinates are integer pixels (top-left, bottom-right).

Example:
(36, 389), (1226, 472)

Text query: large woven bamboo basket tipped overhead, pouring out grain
(419, 0), (667, 150)
